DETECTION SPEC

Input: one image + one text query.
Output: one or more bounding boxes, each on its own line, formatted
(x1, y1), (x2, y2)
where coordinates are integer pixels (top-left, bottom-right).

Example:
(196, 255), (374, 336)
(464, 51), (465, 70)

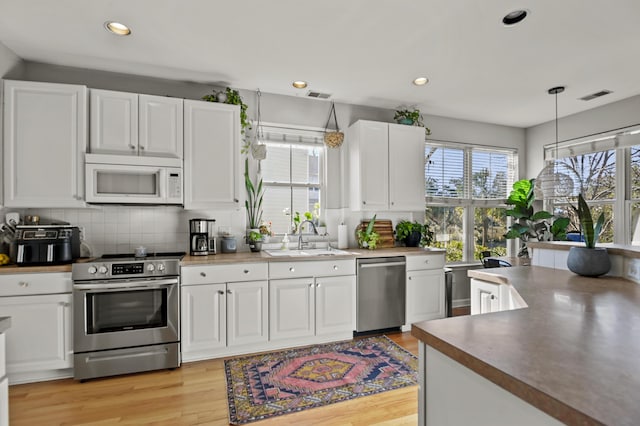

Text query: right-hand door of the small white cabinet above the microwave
(138, 95), (184, 158)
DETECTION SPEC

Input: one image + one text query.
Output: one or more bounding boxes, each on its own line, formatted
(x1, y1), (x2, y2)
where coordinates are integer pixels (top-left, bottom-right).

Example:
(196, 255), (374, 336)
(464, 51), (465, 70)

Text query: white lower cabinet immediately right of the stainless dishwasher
(403, 254), (445, 331)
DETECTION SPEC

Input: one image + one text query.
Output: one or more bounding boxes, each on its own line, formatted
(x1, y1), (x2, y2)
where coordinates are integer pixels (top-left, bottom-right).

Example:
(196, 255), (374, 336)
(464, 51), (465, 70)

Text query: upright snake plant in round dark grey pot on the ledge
(567, 194), (611, 277)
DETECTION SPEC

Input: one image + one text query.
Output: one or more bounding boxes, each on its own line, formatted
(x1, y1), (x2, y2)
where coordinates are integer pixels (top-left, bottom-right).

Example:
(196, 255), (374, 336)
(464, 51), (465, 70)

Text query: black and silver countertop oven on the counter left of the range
(9, 222), (80, 266)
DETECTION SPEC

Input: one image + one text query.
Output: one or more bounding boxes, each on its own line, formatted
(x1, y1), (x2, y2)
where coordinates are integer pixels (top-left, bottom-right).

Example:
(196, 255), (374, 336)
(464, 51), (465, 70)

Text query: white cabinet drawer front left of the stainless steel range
(0, 272), (73, 296)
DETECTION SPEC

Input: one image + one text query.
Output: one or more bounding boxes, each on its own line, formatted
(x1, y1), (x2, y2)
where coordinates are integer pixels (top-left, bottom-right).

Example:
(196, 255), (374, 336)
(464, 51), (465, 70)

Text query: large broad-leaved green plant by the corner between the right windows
(505, 179), (569, 257)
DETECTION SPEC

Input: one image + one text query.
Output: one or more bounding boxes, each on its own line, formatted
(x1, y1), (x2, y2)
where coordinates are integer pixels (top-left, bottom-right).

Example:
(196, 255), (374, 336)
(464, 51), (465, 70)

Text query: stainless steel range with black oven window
(72, 253), (184, 380)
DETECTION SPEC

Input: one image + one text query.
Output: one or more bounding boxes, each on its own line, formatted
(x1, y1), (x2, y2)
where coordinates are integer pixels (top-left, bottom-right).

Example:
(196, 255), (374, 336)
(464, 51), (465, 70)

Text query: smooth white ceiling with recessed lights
(0, 0), (640, 127)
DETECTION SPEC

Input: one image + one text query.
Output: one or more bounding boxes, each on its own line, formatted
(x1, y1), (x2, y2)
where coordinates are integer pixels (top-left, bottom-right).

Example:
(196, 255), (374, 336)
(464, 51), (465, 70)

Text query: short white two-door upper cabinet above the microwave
(90, 89), (183, 158)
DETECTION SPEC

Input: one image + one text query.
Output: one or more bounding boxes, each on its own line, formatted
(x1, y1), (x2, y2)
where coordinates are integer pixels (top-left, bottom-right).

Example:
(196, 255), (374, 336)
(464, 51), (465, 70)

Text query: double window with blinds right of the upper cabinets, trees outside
(425, 143), (516, 262)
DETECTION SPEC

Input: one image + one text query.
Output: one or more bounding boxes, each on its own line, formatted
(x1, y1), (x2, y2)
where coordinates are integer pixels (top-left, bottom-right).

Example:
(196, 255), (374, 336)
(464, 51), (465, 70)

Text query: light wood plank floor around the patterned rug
(9, 333), (418, 426)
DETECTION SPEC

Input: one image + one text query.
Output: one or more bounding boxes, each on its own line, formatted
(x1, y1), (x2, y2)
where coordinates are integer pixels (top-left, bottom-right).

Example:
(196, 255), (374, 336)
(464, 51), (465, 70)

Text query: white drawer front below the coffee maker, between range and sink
(180, 263), (269, 285)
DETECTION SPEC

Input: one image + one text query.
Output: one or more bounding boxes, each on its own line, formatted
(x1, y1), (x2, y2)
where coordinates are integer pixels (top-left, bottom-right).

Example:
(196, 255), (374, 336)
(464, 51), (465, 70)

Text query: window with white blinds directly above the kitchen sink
(260, 127), (324, 234)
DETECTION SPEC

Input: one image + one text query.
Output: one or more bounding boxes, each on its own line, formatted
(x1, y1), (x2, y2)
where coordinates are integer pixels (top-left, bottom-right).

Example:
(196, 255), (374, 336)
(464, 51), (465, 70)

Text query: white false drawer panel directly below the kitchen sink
(269, 259), (356, 278)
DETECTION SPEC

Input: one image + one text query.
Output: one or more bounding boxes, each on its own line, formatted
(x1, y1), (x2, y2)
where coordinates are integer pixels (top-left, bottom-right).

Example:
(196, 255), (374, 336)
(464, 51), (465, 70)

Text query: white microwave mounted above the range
(85, 154), (183, 204)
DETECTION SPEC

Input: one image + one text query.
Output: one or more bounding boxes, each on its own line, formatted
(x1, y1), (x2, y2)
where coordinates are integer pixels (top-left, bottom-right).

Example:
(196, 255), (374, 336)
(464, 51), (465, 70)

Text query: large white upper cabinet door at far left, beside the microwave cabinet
(4, 80), (87, 208)
